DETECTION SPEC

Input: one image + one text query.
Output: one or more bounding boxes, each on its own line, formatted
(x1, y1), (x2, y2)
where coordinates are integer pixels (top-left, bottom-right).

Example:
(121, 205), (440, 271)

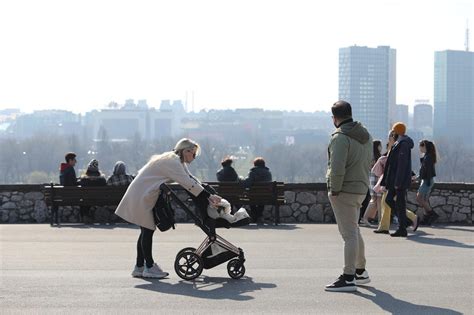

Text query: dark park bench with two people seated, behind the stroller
(208, 181), (285, 225)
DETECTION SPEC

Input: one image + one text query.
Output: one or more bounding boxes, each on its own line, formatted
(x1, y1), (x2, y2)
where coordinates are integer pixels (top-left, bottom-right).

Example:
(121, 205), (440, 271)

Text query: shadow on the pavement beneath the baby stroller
(135, 276), (276, 301)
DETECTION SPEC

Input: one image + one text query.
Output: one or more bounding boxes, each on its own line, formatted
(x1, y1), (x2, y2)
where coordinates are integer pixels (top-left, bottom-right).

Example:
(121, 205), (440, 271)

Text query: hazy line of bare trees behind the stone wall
(0, 130), (474, 184)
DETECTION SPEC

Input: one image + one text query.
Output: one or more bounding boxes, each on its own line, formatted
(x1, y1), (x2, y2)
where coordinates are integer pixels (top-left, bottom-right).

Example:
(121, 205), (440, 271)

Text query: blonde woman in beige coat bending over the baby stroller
(115, 139), (221, 278)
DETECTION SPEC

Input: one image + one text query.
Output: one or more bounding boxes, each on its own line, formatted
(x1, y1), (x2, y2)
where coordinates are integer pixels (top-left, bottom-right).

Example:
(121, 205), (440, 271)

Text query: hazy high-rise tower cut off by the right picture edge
(433, 50), (474, 147)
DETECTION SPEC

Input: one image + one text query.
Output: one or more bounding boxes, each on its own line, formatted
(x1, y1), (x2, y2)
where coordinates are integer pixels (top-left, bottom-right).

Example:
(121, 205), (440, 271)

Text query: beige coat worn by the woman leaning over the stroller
(115, 152), (204, 230)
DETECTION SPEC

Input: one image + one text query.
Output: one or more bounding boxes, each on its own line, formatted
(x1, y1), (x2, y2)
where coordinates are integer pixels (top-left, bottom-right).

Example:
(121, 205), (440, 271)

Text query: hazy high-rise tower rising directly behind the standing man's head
(339, 46), (396, 139)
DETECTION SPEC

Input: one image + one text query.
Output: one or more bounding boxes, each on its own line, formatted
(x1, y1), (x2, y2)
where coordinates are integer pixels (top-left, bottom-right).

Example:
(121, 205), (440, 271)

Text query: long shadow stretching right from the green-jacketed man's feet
(356, 286), (462, 315)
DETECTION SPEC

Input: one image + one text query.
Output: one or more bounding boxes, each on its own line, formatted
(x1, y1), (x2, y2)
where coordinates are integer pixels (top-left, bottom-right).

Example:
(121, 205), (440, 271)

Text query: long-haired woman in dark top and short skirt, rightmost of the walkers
(416, 140), (439, 225)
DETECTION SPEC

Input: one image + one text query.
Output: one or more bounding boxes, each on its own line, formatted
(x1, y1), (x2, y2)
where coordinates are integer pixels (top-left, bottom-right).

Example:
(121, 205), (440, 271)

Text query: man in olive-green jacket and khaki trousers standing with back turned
(326, 101), (372, 292)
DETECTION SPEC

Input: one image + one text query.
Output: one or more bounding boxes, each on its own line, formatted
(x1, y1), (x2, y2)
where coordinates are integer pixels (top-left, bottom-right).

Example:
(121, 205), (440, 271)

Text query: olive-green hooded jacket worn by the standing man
(326, 121), (372, 195)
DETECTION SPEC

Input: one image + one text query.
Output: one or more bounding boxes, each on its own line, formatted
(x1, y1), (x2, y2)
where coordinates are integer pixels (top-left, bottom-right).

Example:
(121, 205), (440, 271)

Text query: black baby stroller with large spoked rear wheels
(160, 184), (250, 280)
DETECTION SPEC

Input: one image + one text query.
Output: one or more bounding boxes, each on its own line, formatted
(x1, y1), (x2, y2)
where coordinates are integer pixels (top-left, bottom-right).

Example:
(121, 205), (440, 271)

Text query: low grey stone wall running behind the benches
(0, 183), (474, 224)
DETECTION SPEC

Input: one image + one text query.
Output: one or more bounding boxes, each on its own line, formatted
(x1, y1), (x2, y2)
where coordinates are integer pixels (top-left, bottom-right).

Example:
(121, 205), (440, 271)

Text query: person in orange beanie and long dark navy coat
(381, 122), (413, 237)
